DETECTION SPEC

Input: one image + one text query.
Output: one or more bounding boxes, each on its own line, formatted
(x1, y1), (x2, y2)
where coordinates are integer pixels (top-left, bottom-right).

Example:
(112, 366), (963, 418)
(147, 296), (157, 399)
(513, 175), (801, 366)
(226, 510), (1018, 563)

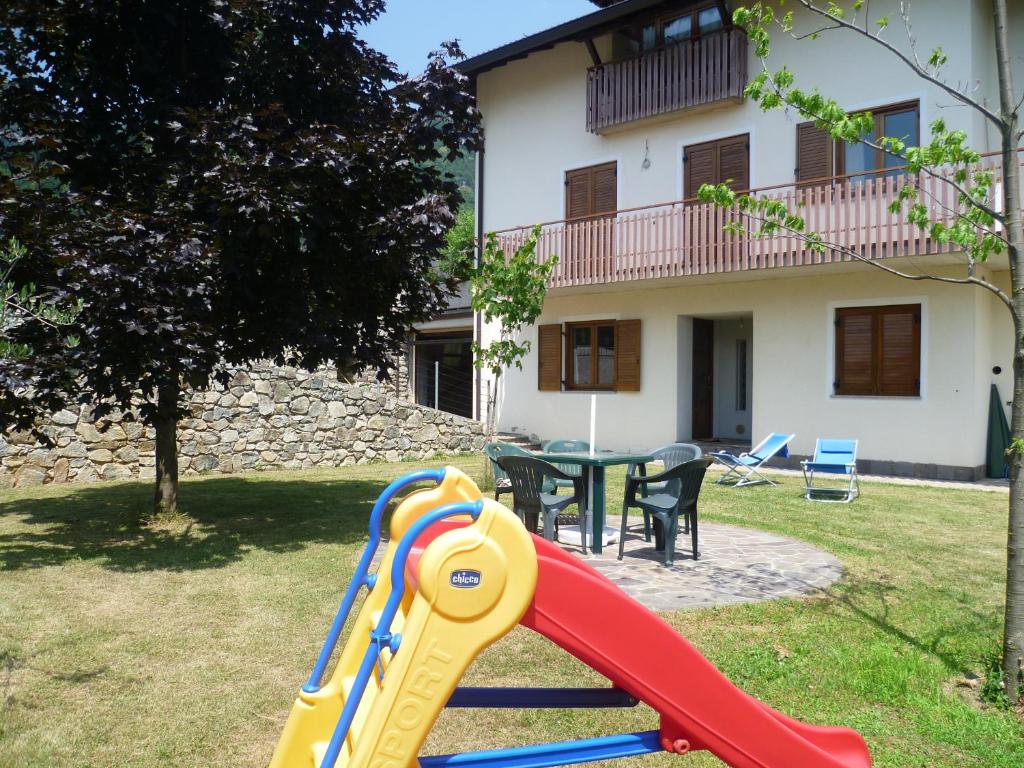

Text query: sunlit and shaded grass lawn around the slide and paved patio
(0, 457), (1024, 768)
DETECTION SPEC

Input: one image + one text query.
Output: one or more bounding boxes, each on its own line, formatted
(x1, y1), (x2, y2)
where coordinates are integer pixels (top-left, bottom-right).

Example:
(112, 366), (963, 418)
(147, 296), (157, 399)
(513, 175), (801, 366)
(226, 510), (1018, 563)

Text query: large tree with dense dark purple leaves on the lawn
(0, 0), (479, 518)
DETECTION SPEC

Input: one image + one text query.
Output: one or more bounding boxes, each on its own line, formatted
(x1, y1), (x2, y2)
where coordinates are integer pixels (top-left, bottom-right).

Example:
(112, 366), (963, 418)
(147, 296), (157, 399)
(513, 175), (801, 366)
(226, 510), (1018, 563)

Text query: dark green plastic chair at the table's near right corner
(618, 457), (713, 567)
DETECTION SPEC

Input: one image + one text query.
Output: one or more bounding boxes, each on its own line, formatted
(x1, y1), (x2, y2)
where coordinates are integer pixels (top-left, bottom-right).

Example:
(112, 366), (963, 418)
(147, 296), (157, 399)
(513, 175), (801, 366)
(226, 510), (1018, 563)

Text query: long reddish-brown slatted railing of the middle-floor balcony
(498, 155), (1024, 288)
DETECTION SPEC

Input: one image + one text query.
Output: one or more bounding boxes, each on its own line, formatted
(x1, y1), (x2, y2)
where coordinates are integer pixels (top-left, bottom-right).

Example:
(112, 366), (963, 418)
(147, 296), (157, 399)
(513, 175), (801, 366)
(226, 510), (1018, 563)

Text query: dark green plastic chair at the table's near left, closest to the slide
(498, 456), (587, 552)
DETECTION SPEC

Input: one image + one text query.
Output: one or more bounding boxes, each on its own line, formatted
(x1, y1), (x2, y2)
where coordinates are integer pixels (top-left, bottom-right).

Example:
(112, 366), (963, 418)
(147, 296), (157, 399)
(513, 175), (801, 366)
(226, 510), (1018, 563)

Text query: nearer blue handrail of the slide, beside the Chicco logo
(321, 501), (483, 768)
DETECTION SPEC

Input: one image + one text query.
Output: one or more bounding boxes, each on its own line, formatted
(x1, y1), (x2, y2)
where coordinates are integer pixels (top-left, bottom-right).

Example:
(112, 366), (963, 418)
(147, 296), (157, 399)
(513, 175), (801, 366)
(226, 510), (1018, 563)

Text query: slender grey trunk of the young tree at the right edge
(992, 0), (1024, 700)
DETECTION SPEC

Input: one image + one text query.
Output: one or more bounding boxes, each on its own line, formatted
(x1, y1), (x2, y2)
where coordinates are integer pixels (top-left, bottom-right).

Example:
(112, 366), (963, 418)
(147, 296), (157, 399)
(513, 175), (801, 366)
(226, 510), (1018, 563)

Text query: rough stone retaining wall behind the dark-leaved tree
(0, 366), (486, 486)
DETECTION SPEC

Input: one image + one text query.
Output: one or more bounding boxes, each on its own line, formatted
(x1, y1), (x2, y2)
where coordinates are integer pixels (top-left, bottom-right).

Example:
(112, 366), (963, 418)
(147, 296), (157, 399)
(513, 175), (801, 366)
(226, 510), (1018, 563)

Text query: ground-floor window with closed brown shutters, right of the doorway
(834, 304), (921, 397)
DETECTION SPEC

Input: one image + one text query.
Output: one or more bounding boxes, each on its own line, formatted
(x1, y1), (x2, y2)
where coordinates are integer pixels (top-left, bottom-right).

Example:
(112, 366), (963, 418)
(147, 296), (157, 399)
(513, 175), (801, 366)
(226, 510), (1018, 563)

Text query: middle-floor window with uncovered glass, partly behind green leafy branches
(796, 101), (921, 181)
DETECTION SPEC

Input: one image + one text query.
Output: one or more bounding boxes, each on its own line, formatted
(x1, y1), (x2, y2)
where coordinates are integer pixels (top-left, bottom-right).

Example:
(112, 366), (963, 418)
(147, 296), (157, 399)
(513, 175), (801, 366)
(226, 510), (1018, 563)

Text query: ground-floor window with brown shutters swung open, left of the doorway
(537, 321), (640, 392)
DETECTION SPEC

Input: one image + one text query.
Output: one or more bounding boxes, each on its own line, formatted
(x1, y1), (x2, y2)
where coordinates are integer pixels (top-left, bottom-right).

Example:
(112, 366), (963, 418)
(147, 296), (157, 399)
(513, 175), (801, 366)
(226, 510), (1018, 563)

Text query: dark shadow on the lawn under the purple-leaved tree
(0, 476), (399, 571)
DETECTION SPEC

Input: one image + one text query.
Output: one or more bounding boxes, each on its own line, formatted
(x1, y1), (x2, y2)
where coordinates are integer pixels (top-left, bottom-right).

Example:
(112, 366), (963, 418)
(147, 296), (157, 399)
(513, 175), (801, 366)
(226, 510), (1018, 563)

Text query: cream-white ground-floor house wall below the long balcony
(499, 268), (1011, 467)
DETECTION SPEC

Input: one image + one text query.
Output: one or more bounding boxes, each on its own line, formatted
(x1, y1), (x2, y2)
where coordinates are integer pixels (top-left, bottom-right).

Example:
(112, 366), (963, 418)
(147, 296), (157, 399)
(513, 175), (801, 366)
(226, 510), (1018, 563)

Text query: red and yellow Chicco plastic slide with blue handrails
(270, 467), (871, 768)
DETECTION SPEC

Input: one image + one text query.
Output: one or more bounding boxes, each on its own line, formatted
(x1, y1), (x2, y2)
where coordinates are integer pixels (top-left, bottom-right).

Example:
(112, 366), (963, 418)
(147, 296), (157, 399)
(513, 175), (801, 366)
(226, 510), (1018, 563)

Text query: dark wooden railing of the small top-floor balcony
(587, 29), (748, 133)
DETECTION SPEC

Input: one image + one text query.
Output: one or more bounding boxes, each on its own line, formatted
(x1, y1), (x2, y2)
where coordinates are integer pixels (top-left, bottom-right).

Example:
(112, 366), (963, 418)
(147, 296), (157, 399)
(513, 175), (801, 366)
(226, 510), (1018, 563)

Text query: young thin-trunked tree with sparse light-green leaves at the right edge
(700, 0), (1024, 698)
